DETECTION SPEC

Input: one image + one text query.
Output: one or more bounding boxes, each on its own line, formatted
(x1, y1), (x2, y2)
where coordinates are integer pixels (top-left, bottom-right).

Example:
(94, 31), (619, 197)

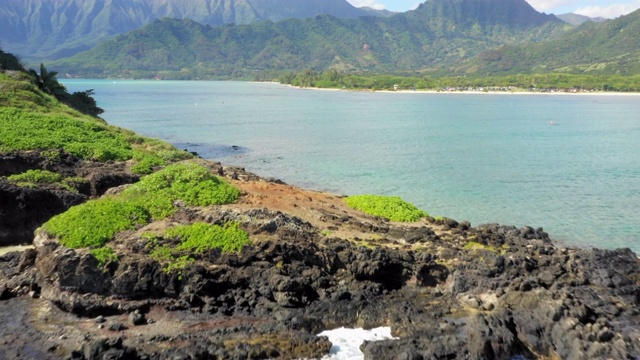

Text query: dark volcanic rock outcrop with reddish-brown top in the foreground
(0, 154), (640, 359)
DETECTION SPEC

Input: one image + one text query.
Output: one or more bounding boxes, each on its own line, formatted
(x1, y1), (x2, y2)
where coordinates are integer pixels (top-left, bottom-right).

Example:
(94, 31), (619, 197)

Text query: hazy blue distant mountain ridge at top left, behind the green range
(0, 0), (388, 61)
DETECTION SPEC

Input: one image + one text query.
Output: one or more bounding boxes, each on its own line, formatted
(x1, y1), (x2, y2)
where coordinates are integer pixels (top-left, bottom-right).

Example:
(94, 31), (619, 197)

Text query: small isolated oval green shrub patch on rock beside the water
(345, 195), (428, 222)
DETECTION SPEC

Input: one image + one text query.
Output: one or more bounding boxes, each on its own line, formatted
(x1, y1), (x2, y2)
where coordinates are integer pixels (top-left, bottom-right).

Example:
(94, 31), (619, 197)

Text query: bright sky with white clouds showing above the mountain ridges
(347, 0), (640, 19)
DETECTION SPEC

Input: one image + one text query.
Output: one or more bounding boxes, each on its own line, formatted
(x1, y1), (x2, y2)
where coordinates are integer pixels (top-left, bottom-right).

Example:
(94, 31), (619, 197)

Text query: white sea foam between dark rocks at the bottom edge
(318, 327), (396, 360)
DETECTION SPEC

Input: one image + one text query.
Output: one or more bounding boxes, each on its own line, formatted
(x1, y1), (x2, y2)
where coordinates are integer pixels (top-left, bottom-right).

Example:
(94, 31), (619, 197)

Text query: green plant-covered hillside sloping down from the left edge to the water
(0, 63), (193, 167)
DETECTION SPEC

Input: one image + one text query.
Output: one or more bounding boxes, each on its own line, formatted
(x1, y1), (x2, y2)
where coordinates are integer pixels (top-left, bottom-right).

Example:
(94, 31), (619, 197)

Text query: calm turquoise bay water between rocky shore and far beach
(64, 80), (640, 252)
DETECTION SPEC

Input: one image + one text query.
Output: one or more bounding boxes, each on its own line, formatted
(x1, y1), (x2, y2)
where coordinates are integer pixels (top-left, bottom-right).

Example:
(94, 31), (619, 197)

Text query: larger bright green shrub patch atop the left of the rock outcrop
(43, 163), (239, 248)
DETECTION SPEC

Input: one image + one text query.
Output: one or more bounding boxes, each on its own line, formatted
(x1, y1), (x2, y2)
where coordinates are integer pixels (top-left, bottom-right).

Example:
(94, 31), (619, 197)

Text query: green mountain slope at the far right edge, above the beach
(462, 10), (640, 75)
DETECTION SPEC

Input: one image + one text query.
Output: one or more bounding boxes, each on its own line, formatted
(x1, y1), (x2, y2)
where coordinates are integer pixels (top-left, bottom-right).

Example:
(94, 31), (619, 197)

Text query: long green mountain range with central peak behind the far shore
(50, 0), (567, 78)
